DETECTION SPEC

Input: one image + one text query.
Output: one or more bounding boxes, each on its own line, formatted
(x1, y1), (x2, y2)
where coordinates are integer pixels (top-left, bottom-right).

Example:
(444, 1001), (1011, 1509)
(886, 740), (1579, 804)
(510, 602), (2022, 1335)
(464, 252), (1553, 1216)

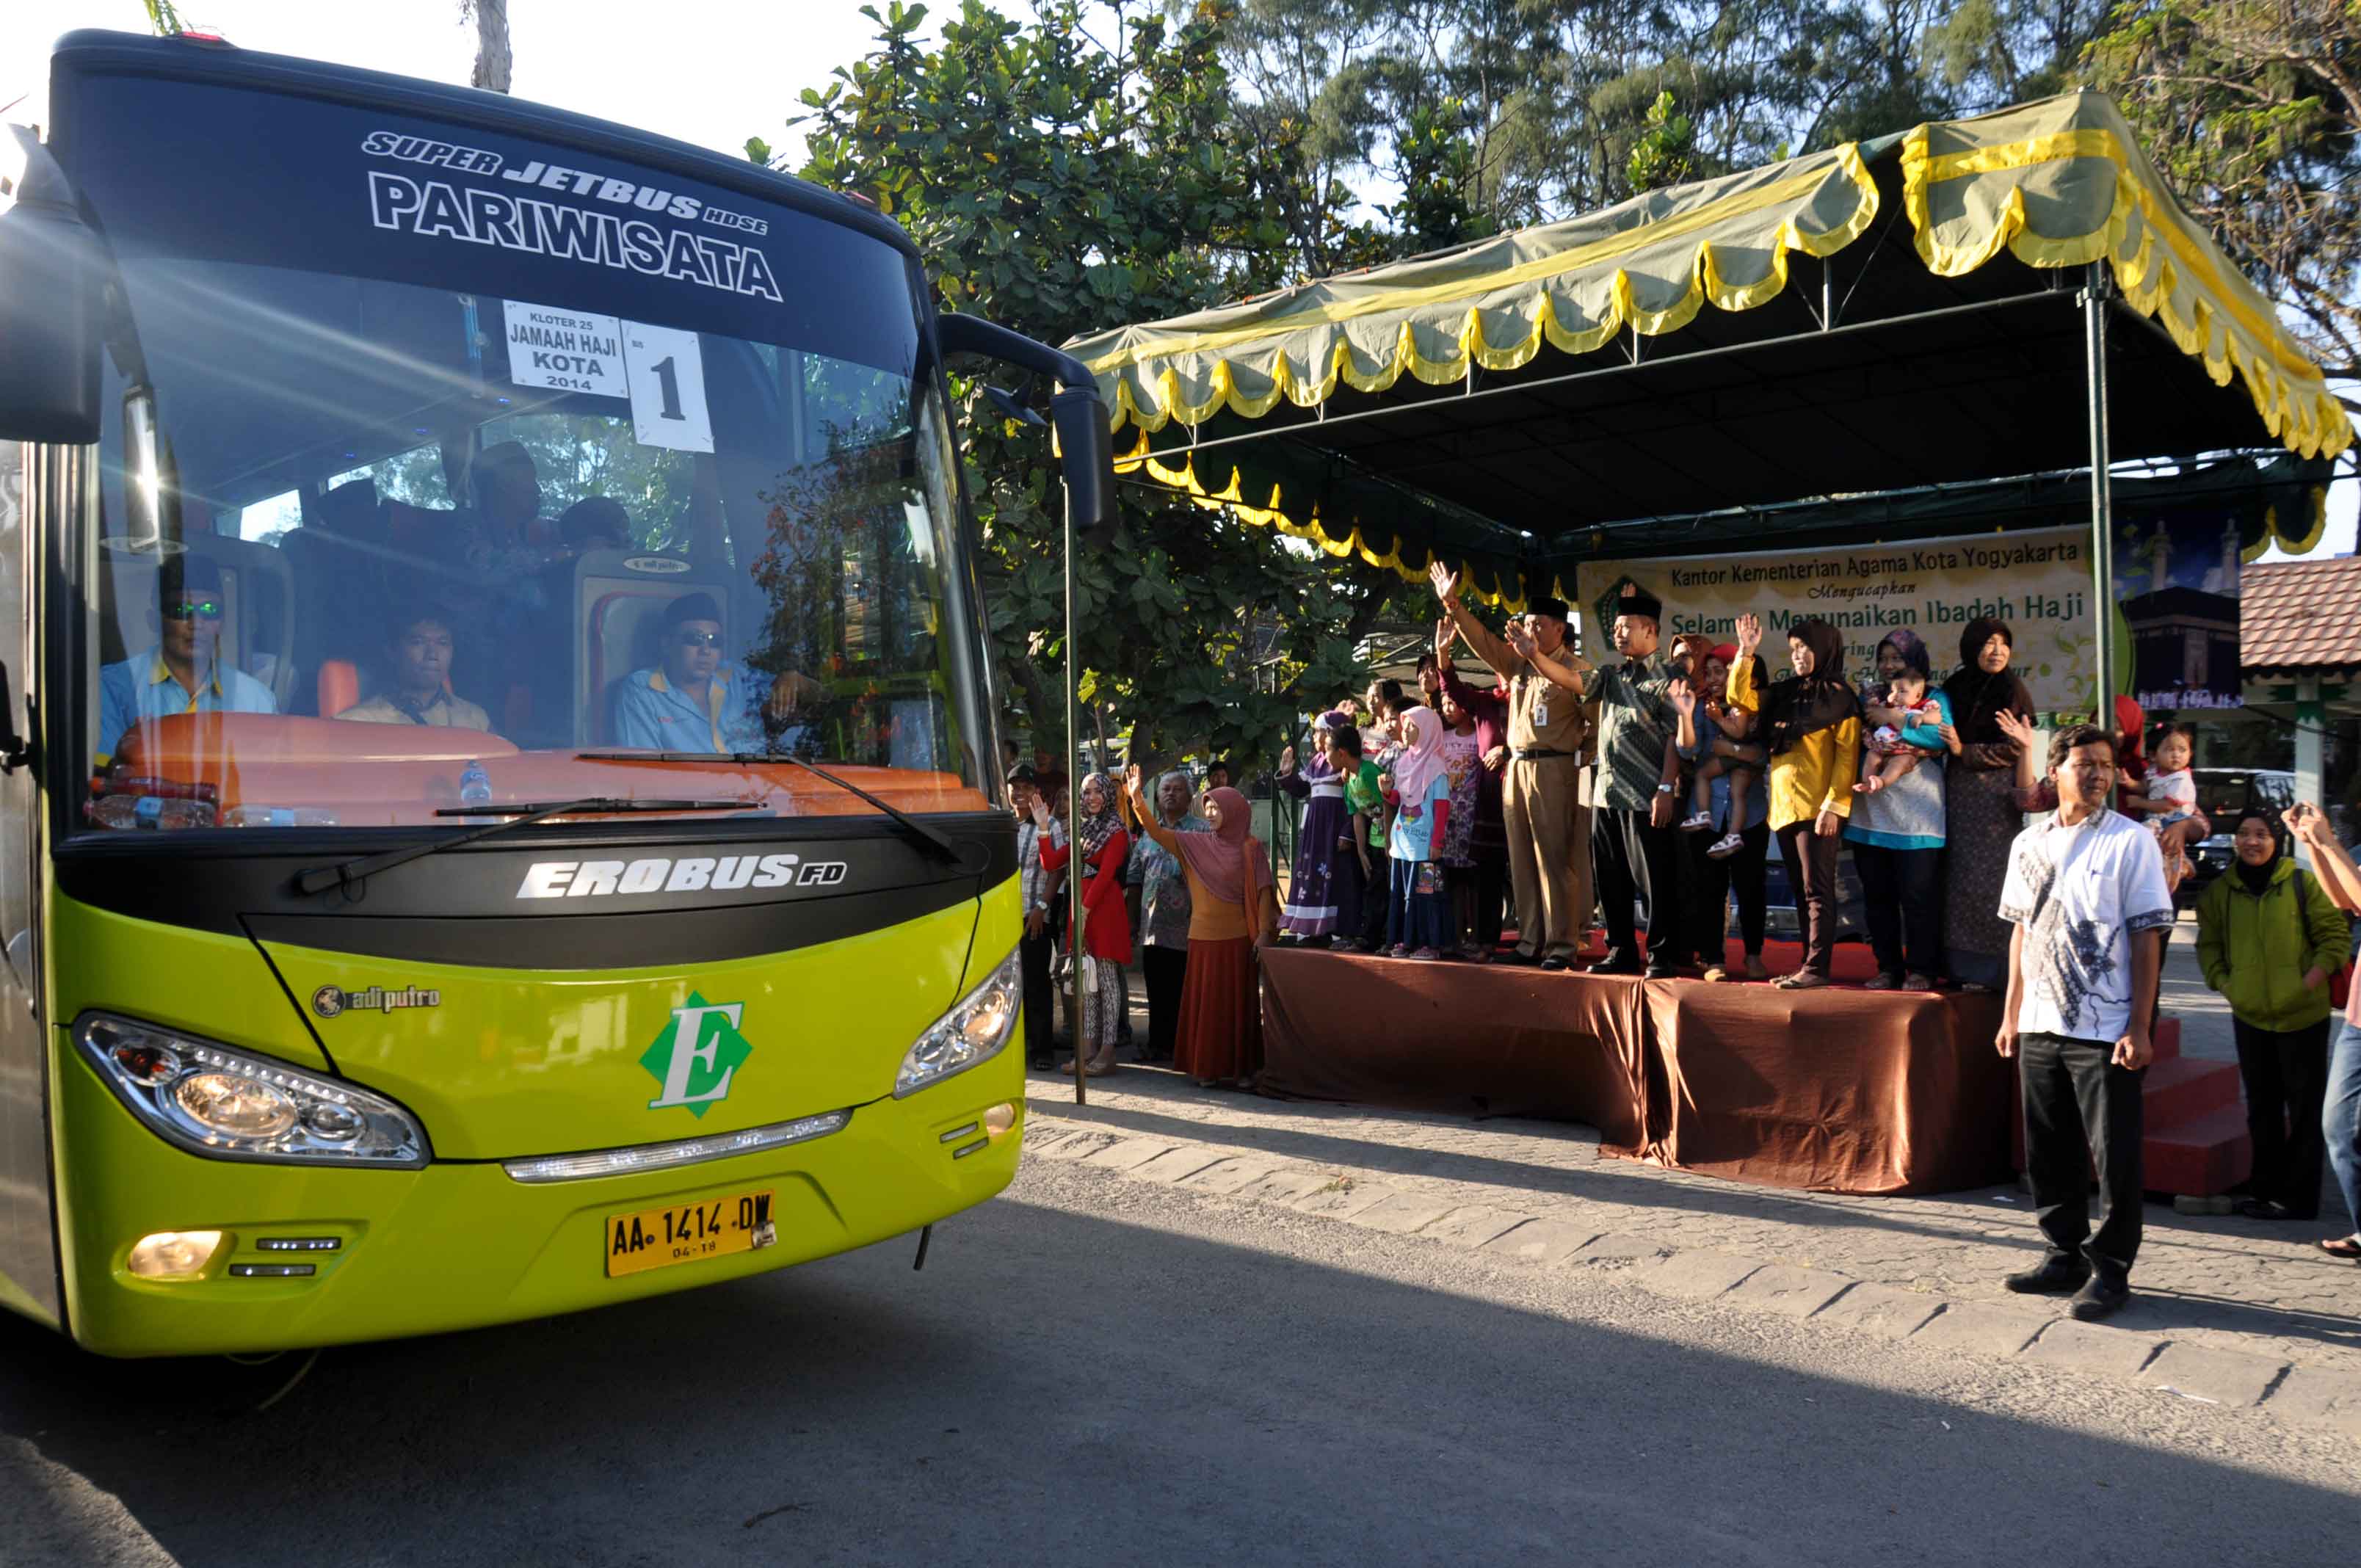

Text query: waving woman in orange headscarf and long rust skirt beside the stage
(1128, 767), (1280, 1089)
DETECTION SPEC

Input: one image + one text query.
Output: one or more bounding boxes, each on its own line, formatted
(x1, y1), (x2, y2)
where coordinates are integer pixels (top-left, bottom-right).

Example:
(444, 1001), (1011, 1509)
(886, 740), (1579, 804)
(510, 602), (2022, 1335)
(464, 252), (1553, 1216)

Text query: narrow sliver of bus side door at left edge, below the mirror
(0, 442), (57, 1322)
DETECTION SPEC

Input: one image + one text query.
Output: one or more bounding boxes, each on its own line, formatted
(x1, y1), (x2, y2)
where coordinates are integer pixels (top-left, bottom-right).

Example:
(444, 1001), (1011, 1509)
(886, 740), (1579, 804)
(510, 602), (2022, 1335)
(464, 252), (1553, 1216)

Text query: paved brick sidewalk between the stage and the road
(1027, 1065), (2361, 1436)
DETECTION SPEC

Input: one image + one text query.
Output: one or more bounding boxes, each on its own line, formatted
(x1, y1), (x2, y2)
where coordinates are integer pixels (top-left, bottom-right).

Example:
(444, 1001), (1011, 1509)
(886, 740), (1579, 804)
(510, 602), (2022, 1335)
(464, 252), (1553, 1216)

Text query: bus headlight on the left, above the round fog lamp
(73, 1013), (427, 1169)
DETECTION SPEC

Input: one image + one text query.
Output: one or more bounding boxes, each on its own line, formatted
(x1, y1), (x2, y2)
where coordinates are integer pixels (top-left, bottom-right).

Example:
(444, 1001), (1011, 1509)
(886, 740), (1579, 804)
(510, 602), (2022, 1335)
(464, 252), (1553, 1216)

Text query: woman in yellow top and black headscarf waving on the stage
(1728, 614), (1860, 992)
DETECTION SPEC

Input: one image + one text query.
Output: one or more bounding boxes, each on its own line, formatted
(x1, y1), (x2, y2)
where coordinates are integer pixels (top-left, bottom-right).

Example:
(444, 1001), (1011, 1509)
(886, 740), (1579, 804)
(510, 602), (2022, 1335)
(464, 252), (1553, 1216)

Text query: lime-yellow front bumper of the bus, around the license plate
(52, 1042), (1025, 1355)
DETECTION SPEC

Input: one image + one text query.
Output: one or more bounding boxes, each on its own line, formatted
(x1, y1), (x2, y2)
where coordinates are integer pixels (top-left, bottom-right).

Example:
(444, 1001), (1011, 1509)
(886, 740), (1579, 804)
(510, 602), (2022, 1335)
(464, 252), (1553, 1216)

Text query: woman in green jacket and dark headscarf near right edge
(2198, 810), (2351, 1219)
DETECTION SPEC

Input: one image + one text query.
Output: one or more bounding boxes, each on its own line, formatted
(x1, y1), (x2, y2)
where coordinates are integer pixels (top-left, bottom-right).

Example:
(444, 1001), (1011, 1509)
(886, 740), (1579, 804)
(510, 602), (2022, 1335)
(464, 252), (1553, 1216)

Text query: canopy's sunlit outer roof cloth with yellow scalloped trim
(1070, 92), (2354, 472)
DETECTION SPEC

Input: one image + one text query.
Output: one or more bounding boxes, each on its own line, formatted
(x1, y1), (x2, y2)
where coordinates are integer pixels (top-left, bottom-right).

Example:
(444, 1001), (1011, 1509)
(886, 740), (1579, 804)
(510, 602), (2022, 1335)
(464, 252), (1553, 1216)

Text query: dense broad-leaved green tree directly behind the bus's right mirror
(748, 0), (1402, 755)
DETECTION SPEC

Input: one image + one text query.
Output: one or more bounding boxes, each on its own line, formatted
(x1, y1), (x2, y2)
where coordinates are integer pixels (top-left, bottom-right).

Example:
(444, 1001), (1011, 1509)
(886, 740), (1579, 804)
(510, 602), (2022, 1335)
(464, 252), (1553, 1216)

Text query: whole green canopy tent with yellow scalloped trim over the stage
(1067, 92), (2354, 689)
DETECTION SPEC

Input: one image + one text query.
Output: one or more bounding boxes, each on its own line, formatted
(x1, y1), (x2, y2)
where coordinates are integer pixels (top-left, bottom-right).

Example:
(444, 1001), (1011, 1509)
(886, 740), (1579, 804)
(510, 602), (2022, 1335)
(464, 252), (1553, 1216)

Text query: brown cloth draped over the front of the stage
(1261, 943), (2012, 1193)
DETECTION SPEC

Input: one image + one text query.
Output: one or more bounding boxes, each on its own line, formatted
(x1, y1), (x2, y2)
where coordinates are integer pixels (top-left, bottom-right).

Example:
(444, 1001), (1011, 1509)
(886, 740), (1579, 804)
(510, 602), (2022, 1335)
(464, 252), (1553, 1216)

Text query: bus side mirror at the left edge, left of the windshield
(0, 125), (104, 446)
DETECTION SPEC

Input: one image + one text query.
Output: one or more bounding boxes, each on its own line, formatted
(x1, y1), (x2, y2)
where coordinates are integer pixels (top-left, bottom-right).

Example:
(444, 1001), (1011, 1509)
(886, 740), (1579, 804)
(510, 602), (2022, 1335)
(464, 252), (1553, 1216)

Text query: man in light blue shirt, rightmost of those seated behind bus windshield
(614, 592), (819, 751)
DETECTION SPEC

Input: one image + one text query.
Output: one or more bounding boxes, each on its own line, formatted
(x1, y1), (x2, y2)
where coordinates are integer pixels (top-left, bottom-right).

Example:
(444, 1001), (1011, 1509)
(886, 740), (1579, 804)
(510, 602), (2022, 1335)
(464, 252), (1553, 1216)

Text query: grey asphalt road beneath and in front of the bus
(0, 1162), (2361, 1568)
